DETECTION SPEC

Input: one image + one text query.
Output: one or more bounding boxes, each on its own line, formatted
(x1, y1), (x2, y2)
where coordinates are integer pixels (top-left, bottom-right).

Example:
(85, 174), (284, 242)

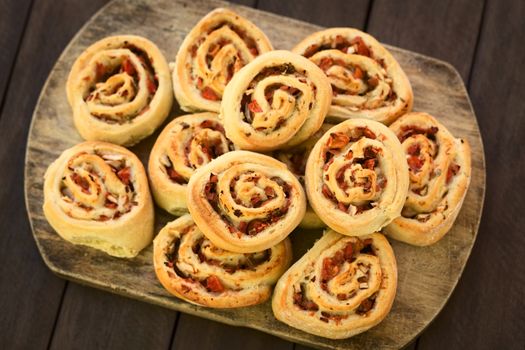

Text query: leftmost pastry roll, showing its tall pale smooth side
(44, 141), (154, 258)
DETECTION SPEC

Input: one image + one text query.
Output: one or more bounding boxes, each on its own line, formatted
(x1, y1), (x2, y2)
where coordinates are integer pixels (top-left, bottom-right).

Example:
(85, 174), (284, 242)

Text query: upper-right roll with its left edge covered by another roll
(292, 28), (414, 124)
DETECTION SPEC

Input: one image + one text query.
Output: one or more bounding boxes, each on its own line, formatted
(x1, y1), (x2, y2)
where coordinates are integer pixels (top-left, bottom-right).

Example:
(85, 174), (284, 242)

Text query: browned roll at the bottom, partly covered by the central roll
(153, 215), (292, 308)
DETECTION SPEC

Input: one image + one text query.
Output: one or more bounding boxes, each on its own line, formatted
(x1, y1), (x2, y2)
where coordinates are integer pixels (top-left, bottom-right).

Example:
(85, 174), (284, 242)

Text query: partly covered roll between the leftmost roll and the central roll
(148, 112), (234, 215)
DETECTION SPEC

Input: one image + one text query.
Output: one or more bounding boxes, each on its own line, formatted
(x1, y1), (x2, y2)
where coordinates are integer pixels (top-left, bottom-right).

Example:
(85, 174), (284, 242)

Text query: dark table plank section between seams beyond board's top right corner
(367, 0), (483, 82)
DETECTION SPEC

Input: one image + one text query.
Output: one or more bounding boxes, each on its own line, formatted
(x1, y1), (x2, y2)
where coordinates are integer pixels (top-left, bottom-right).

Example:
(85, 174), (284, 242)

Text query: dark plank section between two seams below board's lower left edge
(50, 283), (176, 350)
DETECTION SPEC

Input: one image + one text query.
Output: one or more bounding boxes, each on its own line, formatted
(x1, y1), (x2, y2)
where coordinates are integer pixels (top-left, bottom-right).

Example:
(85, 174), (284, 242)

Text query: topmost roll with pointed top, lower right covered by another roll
(173, 8), (273, 112)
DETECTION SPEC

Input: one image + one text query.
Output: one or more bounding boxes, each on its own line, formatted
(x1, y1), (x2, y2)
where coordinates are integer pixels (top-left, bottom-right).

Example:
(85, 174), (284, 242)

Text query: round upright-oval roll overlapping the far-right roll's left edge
(306, 119), (408, 236)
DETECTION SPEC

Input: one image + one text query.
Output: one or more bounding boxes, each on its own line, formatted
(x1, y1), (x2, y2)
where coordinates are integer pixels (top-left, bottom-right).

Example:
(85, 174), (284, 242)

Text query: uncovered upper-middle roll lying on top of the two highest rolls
(220, 51), (332, 151)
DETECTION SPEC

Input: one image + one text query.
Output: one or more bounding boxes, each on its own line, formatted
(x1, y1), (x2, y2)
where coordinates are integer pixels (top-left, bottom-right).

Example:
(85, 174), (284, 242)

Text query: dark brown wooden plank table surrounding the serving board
(0, 0), (525, 350)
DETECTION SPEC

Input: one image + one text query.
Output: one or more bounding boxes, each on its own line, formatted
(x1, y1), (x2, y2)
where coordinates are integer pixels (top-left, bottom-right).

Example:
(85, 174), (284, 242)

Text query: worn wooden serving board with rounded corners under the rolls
(25, 0), (485, 349)
